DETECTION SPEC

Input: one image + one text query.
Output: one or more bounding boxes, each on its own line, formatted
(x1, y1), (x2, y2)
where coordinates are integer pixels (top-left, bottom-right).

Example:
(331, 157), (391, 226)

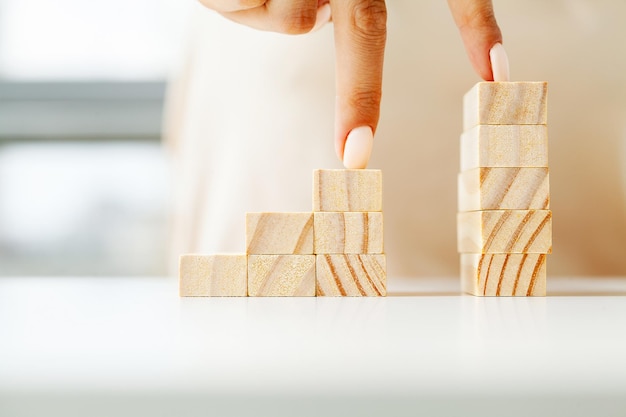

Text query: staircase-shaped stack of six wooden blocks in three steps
(179, 170), (386, 297)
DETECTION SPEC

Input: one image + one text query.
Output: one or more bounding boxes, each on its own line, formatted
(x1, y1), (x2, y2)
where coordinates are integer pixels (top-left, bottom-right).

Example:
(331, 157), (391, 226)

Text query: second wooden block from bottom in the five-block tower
(457, 210), (552, 253)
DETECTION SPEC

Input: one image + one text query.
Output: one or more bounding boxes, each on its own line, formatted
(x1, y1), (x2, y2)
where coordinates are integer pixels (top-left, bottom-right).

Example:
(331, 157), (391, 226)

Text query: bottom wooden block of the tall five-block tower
(461, 253), (547, 296)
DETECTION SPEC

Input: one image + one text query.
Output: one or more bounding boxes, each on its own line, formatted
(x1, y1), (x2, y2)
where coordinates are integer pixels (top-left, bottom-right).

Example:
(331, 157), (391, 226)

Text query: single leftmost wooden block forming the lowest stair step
(179, 254), (248, 297)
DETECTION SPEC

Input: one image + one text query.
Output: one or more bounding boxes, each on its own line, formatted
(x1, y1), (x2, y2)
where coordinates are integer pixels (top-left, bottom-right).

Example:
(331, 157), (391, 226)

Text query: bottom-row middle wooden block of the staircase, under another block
(248, 255), (315, 297)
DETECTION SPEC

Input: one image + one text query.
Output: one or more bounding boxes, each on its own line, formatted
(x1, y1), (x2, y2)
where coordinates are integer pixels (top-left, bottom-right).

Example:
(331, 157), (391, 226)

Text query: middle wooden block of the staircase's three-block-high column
(313, 211), (383, 254)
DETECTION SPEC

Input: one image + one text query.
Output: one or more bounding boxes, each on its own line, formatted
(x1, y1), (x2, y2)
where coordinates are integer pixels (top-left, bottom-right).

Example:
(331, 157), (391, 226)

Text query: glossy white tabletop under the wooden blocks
(0, 277), (626, 417)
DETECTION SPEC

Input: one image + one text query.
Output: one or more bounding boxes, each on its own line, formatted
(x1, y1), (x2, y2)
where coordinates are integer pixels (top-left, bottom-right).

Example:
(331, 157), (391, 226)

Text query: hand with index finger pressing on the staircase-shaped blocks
(200, 0), (387, 168)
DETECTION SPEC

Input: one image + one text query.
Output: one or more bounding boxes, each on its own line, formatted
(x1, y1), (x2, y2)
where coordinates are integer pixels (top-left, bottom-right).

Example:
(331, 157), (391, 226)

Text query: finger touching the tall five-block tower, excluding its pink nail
(448, 0), (500, 81)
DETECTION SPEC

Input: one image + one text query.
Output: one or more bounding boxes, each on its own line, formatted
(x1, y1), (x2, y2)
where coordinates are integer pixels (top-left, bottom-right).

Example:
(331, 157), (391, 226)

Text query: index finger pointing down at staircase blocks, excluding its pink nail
(330, 0), (387, 165)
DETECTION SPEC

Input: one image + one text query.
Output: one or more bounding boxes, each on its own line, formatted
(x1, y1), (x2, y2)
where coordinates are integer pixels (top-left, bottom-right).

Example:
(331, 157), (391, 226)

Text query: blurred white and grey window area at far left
(0, 0), (192, 276)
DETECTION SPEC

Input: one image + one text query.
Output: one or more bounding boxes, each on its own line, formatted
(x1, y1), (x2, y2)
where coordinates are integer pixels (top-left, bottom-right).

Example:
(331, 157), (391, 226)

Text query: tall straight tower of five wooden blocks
(457, 82), (552, 296)
